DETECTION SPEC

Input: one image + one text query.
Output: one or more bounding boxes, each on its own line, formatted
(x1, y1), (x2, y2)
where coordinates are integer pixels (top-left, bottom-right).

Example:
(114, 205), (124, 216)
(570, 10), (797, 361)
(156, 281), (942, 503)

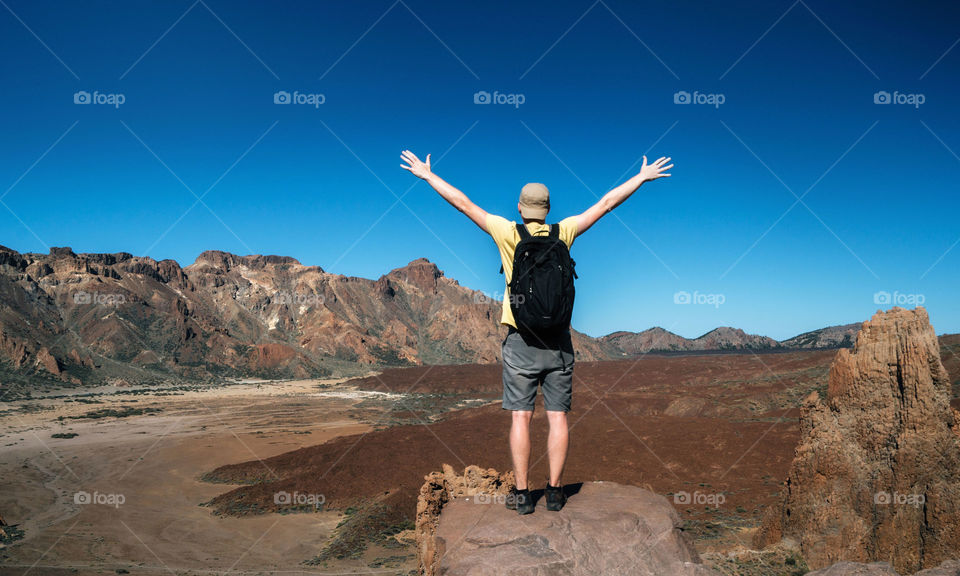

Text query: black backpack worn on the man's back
(500, 223), (577, 337)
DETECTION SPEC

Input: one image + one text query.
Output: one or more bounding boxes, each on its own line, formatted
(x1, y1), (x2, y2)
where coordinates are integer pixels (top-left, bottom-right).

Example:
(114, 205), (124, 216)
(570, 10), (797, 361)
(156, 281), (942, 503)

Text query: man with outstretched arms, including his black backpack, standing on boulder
(400, 150), (673, 514)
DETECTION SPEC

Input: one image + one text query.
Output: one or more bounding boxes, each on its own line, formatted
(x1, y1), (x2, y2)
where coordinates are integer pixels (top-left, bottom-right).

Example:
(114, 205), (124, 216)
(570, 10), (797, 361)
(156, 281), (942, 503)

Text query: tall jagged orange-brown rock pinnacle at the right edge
(755, 308), (960, 574)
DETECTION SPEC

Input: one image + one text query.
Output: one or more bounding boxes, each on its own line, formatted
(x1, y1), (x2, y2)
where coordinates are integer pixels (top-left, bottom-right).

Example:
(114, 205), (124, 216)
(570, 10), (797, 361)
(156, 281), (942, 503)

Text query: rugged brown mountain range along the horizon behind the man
(0, 246), (860, 392)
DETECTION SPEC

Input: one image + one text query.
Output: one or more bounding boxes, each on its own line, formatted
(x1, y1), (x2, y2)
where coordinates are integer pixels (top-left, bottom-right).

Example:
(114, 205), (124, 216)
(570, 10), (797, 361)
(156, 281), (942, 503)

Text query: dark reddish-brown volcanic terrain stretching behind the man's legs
(207, 351), (835, 548)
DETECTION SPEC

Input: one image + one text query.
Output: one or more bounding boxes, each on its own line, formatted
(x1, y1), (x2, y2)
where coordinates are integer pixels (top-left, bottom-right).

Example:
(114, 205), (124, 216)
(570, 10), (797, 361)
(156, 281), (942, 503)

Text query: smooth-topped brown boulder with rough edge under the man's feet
(417, 466), (718, 576)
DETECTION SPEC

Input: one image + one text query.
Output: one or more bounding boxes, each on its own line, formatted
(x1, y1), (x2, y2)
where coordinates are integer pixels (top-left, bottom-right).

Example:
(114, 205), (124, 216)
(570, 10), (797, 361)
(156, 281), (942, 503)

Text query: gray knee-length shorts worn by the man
(501, 328), (574, 412)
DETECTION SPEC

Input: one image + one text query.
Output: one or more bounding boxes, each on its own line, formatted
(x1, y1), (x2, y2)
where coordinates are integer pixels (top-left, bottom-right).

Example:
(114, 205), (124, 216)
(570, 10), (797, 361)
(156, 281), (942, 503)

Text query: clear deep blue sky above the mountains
(0, 0), (960, 339)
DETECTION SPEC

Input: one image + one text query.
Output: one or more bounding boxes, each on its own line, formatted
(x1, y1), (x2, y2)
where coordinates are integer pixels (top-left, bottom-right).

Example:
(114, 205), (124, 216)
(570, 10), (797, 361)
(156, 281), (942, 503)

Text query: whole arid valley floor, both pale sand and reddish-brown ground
(0, 336), (960, 575)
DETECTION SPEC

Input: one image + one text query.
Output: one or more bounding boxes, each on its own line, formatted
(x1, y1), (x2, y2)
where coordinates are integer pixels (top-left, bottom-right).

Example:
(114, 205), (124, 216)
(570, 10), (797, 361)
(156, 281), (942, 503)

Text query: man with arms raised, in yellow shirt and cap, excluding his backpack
(400, 150), (673, 514)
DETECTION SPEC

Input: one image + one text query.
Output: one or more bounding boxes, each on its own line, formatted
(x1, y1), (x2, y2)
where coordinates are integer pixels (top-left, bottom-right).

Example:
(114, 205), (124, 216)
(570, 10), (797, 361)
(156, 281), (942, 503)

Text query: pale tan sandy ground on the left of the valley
(0, 380), (408, 575)
